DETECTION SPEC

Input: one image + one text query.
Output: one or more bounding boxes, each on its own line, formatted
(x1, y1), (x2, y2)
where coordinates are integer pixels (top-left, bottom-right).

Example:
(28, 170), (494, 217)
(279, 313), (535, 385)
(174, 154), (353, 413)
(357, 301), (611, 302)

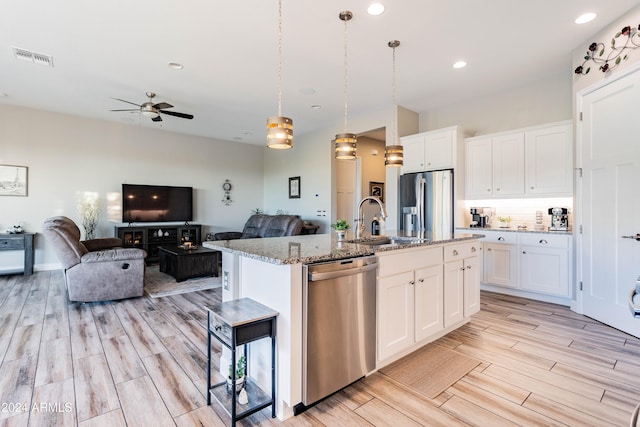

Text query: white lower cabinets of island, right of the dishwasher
(377, 241), (480, 361)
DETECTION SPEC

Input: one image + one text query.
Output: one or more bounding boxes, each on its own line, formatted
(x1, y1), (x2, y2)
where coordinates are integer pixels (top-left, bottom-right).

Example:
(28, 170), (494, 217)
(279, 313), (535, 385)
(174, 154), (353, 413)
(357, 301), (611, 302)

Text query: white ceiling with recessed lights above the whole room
(0, 0), (637, 145)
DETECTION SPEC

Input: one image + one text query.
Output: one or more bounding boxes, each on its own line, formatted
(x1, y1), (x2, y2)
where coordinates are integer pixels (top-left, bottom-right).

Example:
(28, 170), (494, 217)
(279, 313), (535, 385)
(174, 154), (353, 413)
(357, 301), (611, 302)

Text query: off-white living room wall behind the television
(0, 106), (265, 271)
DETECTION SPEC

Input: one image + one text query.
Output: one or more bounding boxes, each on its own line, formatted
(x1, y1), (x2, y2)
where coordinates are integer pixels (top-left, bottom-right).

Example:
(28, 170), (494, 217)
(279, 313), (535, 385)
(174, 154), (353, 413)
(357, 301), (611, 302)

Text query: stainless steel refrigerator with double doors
(398, 169), (454, 237)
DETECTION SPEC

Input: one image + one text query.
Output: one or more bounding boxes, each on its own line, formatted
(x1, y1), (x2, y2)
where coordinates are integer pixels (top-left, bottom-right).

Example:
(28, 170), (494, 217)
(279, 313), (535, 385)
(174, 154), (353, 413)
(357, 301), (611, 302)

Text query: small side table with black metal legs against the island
(205, 298), (278, 426)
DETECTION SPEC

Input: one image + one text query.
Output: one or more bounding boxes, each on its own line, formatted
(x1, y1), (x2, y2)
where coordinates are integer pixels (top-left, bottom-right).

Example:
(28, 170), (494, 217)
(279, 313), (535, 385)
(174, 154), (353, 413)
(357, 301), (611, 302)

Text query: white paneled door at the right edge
(577, 66), (640, 336)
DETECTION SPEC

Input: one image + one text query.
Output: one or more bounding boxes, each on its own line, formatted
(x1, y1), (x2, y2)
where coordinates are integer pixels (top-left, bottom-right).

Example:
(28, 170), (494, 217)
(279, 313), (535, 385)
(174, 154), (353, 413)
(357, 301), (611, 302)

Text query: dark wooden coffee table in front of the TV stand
(158, 245), (220, 282)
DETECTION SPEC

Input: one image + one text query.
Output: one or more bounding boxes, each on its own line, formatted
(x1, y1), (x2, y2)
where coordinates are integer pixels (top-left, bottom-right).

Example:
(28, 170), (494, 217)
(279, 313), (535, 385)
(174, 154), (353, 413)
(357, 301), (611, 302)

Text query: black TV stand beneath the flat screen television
(115, 222), (202, 262)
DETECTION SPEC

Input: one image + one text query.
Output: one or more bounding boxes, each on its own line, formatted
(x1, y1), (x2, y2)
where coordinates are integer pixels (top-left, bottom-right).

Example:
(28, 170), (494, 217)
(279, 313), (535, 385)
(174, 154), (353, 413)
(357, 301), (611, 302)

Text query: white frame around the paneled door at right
(573, 62), (640, 314)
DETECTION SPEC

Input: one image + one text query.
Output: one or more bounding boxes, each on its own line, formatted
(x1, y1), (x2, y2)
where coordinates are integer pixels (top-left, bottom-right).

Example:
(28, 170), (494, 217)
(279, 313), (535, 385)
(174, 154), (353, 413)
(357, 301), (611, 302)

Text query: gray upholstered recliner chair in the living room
(42, 216), (147, 302)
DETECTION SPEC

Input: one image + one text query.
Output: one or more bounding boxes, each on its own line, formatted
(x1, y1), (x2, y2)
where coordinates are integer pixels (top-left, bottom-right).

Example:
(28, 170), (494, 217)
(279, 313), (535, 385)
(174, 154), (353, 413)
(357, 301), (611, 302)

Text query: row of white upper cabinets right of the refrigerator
(465, 122), (573, 199)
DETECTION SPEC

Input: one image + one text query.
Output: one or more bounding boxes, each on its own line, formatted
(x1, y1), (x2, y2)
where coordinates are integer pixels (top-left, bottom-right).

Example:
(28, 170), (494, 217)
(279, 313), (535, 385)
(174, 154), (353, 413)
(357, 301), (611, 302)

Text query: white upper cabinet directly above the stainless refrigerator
(400, 126), (462, 173)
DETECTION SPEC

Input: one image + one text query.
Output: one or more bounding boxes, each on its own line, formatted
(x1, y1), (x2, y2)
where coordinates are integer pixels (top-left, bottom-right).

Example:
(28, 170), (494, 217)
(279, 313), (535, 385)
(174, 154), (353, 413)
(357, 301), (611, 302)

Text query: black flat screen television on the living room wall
(122, 184), (193, 223)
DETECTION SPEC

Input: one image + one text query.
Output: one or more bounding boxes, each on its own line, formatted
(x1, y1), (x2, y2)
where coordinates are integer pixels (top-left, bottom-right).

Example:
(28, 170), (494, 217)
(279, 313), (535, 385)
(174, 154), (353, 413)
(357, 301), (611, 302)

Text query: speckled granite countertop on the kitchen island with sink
(202, 230), (482, 264)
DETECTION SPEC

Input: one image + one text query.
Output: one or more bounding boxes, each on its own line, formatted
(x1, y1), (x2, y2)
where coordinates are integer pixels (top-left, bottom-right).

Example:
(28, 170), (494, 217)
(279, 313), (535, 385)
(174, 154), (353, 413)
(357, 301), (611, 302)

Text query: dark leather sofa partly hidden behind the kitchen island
(213, 214), (304, 240)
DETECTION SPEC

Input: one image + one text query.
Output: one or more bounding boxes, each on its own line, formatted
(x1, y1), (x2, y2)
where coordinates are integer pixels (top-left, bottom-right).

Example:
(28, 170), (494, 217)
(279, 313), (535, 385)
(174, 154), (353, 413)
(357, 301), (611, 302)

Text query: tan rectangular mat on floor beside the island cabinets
(380, 344), (480, 399)
